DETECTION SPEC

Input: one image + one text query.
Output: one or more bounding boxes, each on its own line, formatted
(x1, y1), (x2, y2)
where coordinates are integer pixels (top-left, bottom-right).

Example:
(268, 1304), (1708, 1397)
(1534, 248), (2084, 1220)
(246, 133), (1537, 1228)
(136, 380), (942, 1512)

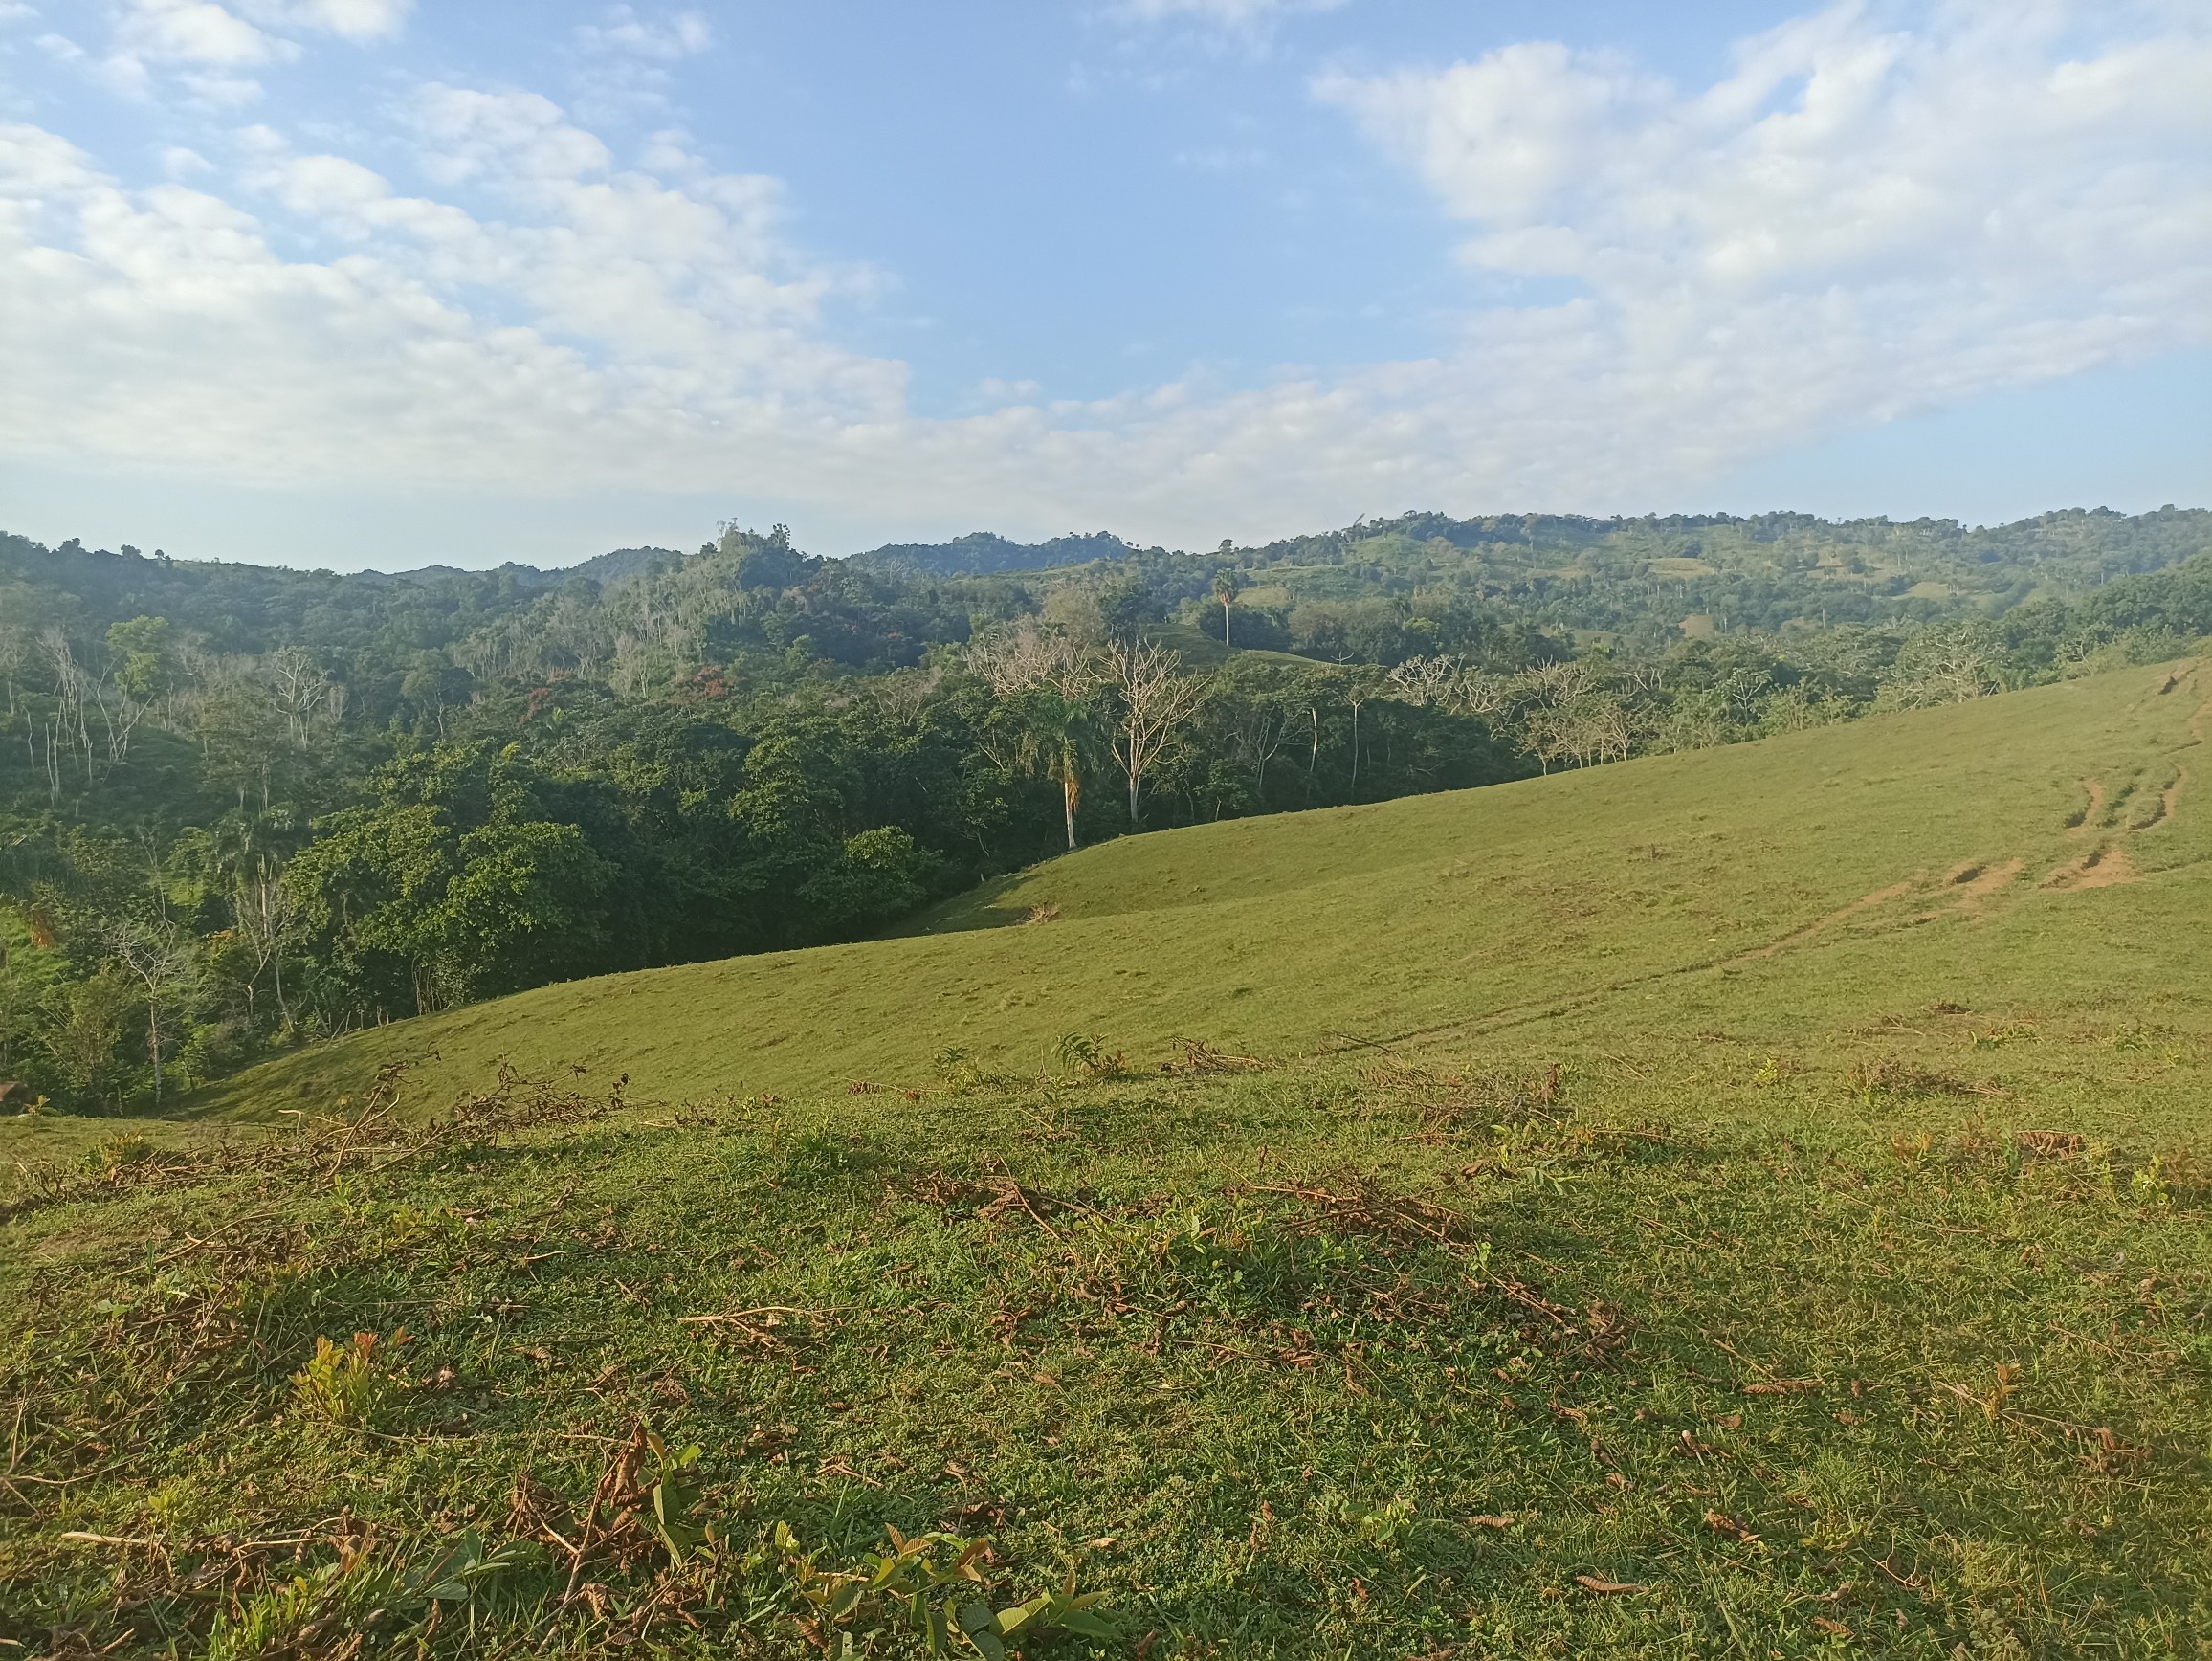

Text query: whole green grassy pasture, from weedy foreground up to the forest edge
(0, 668), (2212, 1661)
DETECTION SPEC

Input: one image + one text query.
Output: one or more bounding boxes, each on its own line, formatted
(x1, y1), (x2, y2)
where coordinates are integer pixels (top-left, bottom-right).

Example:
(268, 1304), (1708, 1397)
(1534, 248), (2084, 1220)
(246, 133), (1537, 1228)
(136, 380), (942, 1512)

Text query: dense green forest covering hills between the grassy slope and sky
(0, 509), (2212, 1110)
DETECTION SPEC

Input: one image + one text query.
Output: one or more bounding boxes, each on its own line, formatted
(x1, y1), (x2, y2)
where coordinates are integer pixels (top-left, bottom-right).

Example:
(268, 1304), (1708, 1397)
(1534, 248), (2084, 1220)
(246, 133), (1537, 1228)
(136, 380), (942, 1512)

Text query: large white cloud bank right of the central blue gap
(1316, 0), (2212, 464)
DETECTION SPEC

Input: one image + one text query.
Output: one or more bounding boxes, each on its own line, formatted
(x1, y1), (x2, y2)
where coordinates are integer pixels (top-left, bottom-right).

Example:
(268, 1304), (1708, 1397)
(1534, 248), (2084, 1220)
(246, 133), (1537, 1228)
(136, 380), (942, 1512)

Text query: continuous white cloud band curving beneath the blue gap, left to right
(0, 0), (2212, 540)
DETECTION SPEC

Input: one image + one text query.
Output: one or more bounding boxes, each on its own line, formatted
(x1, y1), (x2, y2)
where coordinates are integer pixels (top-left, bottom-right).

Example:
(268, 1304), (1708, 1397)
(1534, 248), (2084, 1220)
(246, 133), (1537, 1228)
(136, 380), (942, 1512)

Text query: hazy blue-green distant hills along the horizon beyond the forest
(17, 506), (2212, 628)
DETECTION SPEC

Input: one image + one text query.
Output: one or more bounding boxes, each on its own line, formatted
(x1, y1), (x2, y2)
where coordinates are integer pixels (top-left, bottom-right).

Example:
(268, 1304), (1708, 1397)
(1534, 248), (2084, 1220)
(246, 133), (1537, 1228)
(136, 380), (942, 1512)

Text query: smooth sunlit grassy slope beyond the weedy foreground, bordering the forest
(181, 654), (2212, 1115)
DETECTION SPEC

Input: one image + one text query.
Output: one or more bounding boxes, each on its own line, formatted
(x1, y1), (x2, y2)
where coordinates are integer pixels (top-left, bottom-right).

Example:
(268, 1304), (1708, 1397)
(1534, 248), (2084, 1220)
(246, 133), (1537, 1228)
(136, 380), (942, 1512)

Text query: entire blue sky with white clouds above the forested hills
(0, 0), (2212, 568)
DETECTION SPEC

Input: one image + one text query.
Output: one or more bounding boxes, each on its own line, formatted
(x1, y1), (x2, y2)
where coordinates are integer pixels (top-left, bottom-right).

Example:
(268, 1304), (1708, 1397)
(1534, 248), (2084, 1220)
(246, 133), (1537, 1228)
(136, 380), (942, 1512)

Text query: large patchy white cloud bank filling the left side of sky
(0, 86), (905, 504)
